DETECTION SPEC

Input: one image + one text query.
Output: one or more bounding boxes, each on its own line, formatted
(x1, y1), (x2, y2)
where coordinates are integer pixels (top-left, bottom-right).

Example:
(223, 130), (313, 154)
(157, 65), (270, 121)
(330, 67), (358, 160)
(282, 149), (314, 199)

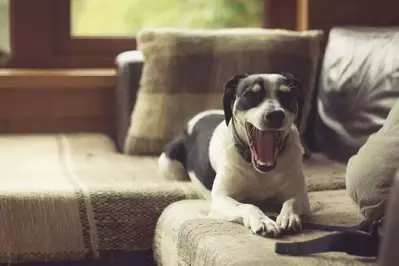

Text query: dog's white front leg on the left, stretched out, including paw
(210, 194), (280, 237)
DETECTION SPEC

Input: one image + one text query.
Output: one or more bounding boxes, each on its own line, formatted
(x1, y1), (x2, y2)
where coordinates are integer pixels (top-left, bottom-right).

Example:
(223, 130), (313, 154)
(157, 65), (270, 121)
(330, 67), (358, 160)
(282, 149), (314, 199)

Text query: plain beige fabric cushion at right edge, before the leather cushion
(346, 99), (399, 219)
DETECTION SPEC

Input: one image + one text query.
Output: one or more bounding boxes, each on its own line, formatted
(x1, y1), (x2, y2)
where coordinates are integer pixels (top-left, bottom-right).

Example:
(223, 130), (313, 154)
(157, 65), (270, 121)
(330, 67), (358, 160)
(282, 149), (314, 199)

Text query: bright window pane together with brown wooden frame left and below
(7, 0), (277, 68)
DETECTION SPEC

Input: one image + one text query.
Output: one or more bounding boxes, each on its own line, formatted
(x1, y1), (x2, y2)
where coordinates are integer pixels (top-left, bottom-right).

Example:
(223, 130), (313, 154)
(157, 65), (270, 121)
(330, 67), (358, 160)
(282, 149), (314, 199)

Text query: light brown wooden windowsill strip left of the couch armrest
(0, 68), (116, 89)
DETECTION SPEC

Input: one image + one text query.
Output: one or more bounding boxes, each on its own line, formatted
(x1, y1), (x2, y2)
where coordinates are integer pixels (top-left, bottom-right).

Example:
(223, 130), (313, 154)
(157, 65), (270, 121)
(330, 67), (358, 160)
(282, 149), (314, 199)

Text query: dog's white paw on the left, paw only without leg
(244, 215), (280, 237)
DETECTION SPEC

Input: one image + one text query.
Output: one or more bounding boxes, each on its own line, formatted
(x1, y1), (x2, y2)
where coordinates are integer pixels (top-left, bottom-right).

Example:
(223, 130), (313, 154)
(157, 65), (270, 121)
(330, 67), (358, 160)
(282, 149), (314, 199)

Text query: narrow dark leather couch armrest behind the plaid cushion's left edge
(115, 51), (144, 152)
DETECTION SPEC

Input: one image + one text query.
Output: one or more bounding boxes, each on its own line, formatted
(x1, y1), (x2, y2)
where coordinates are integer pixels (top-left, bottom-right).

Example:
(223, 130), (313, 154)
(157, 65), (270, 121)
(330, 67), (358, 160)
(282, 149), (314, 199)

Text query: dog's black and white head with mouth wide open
(223, 74), (301, 172)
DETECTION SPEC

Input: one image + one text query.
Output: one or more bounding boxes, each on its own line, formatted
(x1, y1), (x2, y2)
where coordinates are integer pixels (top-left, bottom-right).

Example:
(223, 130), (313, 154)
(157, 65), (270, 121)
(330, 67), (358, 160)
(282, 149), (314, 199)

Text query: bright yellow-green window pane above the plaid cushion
(71, 0), (263, 36)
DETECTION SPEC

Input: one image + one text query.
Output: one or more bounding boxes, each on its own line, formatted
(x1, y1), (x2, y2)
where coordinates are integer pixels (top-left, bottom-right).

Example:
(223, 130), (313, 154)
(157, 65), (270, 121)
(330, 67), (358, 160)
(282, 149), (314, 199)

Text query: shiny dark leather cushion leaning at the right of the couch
(315, 27), (399, 162)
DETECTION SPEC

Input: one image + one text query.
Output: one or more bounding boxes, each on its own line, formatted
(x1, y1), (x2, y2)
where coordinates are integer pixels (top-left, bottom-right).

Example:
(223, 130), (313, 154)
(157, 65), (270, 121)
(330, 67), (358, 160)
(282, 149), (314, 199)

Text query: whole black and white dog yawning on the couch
(159, 74), (310, 237)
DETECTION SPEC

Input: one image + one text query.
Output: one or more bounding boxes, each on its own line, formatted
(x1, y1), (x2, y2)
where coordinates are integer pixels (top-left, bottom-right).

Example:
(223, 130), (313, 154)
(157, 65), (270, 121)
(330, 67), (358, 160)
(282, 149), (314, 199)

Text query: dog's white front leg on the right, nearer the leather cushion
(276, 191), (310, 232)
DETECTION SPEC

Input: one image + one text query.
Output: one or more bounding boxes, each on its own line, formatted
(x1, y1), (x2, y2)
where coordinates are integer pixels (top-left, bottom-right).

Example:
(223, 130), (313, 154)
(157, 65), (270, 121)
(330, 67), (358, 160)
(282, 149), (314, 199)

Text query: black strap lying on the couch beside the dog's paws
(275, 218), (383, 257)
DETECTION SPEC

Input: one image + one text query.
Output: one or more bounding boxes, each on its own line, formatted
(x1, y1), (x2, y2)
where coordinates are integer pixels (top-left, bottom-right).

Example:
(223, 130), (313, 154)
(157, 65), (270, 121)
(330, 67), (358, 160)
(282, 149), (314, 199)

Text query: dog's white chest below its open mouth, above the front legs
(209, 122), (304, 200)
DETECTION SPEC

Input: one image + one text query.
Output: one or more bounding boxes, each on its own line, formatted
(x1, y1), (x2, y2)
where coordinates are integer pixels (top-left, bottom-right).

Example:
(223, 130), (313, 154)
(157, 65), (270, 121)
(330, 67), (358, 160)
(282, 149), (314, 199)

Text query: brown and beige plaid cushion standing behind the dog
(124, 29), (322, 154)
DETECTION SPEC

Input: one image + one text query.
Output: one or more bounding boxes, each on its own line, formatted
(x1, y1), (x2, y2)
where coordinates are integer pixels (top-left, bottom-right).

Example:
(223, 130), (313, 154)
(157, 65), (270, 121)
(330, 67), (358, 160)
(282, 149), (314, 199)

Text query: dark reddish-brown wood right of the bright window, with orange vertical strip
(264, 0), (399, 52)
